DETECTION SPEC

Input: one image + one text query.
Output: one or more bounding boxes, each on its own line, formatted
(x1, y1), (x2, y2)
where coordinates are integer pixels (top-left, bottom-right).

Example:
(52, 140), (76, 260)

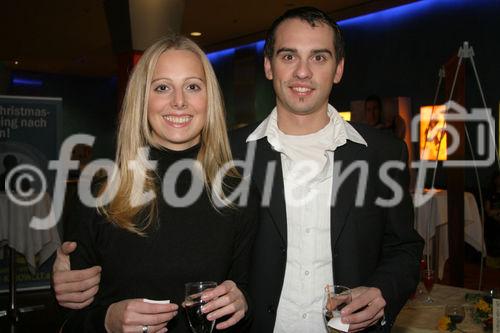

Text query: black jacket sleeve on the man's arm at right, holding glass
(367, 142), (424, 327)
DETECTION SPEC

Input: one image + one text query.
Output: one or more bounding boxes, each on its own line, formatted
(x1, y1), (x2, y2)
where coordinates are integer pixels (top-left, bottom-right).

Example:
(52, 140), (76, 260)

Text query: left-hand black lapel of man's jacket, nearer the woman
(253, 138), (287, 246)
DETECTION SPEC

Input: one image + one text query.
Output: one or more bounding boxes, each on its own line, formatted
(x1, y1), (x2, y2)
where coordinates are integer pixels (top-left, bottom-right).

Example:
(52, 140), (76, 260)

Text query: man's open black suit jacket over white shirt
(230, 124), (423, 333)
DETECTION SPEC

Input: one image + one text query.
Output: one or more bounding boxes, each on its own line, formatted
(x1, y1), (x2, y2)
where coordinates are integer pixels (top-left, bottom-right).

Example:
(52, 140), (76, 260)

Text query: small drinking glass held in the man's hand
(323, 284), (352, 333)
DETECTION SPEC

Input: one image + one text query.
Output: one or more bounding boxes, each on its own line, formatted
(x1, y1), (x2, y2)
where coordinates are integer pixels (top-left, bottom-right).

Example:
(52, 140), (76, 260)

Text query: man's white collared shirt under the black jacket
(247, 105), (367, 333)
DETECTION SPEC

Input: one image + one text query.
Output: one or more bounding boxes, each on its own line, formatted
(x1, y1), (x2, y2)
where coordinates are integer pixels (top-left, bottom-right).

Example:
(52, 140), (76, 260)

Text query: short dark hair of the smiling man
(264, 7), (345, 62)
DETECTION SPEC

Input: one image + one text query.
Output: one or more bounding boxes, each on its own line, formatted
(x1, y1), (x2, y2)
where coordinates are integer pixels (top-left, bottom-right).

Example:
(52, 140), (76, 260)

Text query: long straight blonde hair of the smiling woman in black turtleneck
(99, 35), (237, 235)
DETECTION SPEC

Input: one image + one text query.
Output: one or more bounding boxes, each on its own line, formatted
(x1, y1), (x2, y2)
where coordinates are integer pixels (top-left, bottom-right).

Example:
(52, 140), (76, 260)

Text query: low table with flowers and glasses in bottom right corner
(392, 284), (483, 333)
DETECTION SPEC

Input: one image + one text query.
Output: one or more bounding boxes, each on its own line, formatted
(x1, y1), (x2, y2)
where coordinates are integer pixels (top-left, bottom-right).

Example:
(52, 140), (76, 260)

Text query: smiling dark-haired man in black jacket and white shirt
(231, 7), (423, 333)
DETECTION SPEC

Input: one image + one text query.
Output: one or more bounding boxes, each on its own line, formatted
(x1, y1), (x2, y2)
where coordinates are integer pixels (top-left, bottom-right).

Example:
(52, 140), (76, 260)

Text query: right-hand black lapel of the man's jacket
(330, 141), (363, 249)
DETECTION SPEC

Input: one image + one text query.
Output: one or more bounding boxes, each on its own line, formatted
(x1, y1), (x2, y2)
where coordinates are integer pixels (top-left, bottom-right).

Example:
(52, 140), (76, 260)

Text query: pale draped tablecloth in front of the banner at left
(0, 193), (61, 273)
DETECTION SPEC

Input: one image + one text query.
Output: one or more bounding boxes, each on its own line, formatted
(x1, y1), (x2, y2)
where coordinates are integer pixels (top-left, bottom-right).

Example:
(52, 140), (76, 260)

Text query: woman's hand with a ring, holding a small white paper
(104, 298), (178, 333)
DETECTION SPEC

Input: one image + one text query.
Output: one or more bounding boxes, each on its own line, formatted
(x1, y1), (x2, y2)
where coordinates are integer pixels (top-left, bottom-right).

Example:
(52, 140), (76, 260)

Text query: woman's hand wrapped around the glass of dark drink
(197, 280), (248, 330)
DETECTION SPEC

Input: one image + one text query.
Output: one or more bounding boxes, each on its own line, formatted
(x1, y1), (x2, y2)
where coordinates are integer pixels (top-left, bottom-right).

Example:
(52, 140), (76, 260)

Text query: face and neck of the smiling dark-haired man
(264, 18), (344, 135)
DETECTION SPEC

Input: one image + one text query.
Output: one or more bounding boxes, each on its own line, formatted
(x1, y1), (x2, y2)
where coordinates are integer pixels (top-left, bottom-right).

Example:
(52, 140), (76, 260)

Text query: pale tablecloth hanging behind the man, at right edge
(415, 190), (486, 279)
